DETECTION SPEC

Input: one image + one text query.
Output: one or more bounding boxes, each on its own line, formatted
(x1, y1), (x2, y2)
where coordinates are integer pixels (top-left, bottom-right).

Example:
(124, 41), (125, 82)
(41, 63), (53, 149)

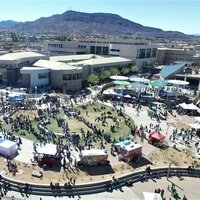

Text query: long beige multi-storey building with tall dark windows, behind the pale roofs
(44, 39), (157, 68)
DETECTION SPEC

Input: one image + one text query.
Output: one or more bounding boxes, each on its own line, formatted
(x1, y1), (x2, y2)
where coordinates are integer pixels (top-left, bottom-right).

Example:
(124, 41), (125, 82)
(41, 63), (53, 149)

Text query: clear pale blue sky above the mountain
(0, 0), (200, 34)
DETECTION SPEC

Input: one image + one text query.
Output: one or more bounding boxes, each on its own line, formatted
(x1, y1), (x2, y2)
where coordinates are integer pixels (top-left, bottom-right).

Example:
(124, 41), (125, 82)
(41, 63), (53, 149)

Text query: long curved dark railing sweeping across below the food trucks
(0, 168), (200, 196)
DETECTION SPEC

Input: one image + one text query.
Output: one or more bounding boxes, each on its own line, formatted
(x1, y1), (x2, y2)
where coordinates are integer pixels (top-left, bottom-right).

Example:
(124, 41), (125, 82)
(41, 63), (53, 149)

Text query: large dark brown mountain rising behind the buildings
(8, 11), (189, 38)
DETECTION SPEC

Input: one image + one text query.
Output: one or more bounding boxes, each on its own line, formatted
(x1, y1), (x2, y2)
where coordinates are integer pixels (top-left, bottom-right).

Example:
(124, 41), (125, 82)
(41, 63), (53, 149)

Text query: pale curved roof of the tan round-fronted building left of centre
(33, 60), (82, 70)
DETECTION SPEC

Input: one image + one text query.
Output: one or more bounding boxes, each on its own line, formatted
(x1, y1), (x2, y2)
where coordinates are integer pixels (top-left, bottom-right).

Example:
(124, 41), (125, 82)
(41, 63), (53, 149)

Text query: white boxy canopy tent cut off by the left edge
(0, 138), (18, 157)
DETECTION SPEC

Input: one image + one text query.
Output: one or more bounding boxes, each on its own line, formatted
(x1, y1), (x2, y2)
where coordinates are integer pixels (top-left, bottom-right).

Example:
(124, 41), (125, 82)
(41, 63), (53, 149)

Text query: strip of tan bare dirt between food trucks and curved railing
(0, 148), (200, 184)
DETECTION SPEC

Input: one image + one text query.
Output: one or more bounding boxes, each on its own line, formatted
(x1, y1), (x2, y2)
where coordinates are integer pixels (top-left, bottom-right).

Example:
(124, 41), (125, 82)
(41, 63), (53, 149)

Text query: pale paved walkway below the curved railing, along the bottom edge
(2, 177), (200, 200)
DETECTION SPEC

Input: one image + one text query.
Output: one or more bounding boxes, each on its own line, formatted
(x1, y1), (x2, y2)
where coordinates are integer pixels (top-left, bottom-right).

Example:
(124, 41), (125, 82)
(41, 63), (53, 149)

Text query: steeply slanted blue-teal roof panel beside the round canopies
(160, 62), (189, 78)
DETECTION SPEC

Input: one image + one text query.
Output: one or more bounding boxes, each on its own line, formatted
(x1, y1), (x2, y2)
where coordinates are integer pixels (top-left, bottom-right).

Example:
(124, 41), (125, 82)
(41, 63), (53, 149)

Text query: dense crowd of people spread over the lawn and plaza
(1, 86), (200, 199)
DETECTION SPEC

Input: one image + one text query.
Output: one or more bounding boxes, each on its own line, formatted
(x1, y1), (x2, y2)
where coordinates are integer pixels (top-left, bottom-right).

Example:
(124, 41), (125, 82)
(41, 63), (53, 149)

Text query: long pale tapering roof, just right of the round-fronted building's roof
(71, 57), (133, 65)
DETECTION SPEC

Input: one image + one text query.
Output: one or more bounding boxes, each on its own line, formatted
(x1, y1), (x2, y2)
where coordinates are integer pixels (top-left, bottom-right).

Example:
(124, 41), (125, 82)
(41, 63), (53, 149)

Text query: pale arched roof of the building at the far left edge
(0, 52), (46, 61)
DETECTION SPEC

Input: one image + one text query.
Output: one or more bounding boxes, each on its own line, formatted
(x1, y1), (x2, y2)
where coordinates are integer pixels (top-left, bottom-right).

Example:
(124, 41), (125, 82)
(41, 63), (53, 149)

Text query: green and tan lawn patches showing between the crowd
(2, 103), (134, 141)
